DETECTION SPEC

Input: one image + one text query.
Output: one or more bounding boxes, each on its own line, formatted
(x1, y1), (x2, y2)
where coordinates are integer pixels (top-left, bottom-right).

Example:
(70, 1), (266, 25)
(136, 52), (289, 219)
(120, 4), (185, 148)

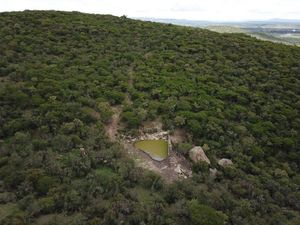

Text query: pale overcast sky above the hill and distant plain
(0, 0), (300, 21)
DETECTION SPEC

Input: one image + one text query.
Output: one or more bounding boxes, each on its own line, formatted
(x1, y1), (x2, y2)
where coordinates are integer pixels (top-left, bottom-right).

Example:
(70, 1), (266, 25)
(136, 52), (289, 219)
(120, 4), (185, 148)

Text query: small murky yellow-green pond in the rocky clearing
(134, 140), (168, 161)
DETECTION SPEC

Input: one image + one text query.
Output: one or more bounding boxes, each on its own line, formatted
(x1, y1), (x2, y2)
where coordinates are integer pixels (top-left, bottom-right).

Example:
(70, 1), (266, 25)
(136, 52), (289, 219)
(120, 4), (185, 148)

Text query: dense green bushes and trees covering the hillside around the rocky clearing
(0, 11), (300, 225)
